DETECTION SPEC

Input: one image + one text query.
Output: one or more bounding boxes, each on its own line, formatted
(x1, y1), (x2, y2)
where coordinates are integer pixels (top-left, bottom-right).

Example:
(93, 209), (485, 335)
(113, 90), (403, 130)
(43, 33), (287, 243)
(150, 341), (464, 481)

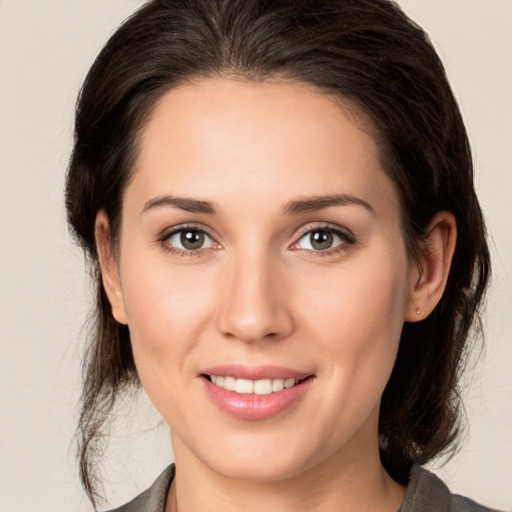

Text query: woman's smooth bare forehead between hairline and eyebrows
(128, 78), (396, 219)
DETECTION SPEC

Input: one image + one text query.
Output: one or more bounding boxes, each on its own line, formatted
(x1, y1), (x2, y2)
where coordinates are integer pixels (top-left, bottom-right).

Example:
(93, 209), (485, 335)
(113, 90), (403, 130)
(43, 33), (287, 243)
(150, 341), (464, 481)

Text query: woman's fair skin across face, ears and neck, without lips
(96, 78), (456, 512)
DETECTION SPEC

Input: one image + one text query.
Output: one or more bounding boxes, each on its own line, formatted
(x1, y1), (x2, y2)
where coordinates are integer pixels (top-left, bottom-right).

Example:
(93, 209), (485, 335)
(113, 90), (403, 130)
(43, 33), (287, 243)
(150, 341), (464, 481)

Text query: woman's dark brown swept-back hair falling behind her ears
(66, 0), (490, 502)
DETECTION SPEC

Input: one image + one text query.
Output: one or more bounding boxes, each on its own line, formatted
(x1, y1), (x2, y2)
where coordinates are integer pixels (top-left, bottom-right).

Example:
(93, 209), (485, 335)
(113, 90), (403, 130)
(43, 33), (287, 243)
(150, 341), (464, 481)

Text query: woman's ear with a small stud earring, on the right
(405, 211), (457, 322)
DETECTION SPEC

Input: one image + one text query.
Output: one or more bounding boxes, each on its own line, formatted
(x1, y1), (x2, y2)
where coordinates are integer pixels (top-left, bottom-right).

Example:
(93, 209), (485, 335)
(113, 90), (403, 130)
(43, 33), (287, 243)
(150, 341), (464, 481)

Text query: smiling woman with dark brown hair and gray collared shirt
(66, 0), (500, 512)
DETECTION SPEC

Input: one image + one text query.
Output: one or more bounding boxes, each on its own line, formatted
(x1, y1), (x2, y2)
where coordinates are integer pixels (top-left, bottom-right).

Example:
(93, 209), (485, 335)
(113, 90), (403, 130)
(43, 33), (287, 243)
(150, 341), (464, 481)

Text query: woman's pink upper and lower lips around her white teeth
(202, 365), (314, 420)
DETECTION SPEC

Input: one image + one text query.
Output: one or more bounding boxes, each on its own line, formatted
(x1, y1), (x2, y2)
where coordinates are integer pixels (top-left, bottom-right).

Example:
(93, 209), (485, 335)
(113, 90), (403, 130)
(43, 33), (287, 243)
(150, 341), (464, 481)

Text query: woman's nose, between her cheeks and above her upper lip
(218, 250), (294, 343)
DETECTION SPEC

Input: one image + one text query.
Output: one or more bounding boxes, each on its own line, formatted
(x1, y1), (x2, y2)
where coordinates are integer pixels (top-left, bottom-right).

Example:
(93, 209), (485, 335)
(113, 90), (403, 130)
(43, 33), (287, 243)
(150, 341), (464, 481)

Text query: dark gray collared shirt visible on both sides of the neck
(104, 464), (497, 512)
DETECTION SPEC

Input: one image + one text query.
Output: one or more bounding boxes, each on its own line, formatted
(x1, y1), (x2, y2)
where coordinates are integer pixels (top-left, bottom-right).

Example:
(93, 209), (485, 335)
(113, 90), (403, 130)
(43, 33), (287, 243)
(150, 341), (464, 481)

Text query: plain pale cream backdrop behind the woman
(0, 0), (512, 512)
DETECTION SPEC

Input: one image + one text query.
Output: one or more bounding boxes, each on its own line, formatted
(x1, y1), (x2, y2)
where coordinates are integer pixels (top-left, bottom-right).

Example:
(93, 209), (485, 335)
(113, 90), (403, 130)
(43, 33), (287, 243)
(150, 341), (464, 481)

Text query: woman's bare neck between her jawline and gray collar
(166, 430), (405, 512)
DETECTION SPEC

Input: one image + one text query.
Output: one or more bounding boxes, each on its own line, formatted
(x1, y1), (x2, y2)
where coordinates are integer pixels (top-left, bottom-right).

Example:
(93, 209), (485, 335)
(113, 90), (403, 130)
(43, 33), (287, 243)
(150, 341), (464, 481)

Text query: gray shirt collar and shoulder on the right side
(398, 466), (498, 512)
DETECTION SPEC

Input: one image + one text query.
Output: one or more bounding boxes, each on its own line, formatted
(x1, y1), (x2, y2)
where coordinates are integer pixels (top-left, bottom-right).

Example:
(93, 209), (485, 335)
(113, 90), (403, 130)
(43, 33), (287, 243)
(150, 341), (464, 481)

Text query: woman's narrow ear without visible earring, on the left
(94, 210), (127, 325)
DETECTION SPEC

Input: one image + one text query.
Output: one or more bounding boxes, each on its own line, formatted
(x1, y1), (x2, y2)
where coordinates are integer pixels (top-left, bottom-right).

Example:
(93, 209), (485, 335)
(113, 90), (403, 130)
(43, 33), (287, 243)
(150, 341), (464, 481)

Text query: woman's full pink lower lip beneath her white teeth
(203, 377), (313, 420)
